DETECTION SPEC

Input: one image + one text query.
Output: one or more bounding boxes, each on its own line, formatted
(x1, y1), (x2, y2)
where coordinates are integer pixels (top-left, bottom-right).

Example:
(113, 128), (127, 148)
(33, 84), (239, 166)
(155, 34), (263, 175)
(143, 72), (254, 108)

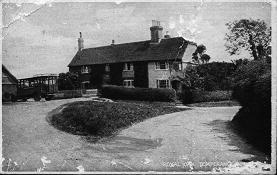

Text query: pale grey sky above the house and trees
(2, 1), (271, 78)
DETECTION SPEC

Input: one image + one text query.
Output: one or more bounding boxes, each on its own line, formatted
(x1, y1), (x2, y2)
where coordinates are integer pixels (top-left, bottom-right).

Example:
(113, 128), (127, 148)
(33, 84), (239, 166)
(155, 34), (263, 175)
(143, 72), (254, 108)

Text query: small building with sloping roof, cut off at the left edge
(2, 64), (17, 101)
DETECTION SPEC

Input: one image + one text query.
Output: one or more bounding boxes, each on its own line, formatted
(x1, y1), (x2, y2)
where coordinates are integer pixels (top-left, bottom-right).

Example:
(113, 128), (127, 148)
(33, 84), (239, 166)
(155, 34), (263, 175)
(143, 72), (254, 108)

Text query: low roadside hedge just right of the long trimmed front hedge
(181, 89), (232, 104)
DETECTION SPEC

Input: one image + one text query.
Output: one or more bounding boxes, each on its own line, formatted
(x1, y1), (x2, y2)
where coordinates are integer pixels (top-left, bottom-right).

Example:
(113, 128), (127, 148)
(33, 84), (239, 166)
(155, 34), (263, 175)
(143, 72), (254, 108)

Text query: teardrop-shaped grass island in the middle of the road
(48, 101), (186, 137)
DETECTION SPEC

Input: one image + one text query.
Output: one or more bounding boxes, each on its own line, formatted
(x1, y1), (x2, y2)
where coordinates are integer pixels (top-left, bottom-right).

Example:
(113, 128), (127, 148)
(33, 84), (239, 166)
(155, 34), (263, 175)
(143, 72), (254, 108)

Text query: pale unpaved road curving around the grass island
(2, 98), (265, 171)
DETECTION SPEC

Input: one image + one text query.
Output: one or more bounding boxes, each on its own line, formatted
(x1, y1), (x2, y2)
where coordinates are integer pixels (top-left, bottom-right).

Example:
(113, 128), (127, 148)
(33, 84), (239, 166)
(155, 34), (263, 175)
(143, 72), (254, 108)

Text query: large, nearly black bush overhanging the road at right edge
(232, 60), (271, 153)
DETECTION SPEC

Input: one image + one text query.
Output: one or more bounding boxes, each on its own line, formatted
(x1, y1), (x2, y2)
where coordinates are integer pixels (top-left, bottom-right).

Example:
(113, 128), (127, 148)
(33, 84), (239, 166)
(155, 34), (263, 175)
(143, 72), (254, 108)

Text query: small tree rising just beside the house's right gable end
(192, 44), (211, 64)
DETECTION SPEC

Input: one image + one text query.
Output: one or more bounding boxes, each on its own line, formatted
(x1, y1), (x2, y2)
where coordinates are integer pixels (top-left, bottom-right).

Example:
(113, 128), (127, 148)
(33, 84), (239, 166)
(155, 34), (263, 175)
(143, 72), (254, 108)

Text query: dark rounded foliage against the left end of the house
(58, 72), (81, 90)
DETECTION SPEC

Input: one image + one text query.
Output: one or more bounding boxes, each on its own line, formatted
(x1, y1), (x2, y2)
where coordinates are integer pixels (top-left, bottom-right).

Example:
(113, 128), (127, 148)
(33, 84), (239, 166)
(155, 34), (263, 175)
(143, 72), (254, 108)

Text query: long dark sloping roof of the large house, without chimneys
(68, 37), (196, 67)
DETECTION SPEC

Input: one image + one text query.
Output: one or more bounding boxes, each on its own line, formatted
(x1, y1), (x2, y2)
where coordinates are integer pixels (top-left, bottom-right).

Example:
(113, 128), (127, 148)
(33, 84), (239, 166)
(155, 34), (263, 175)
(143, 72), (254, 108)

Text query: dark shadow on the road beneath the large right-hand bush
(207, 120), (270, 162)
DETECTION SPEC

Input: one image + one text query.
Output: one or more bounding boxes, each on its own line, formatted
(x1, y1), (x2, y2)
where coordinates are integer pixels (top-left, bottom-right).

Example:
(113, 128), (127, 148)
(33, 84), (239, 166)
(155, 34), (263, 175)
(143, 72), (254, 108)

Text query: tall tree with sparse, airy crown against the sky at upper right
(225, 19), (271, 60)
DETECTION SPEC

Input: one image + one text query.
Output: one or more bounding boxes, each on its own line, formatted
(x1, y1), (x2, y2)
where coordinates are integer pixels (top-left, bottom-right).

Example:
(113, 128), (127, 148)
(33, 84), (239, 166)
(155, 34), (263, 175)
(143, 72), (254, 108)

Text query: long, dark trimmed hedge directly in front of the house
(101, 85), (176, 102)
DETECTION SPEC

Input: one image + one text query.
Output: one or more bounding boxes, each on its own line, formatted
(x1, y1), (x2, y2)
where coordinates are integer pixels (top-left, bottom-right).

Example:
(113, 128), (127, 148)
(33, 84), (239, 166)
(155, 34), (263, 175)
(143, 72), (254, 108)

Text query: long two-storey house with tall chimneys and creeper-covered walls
(68, 20), (197, 91)
